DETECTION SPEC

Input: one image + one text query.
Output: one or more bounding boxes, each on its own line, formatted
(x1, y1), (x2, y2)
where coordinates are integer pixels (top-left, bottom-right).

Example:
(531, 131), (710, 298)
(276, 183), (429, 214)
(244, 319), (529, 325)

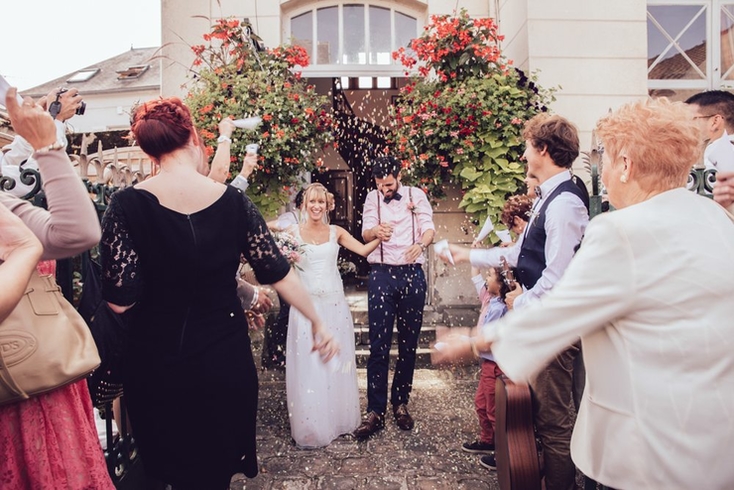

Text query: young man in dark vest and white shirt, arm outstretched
(442, 114), (589, 490)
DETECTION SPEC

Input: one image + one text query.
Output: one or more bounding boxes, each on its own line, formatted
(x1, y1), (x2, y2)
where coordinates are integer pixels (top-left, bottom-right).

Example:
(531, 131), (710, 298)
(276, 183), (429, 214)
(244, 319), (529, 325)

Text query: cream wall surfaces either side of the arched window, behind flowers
(161, 0), (647, 148)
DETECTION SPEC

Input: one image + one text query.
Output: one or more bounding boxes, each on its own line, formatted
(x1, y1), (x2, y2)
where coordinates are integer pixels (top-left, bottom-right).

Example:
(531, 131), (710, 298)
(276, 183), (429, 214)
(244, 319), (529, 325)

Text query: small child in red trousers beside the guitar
(461, 267), (509, 470)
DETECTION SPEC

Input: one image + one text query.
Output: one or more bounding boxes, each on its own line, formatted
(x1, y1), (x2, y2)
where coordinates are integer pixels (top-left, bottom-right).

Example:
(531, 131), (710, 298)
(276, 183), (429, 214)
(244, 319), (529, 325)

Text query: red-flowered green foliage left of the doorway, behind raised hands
(187, 18), (331, 216)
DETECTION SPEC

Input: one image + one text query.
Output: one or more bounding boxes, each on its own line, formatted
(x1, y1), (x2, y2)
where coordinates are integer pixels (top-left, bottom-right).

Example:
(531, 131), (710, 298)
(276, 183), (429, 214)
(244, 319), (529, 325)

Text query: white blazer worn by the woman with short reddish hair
(486, 189), (734, 490)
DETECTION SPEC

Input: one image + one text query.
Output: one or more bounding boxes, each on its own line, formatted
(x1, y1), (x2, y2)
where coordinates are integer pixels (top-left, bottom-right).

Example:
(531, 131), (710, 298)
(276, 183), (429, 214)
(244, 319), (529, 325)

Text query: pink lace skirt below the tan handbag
(0, 380), (115, 490)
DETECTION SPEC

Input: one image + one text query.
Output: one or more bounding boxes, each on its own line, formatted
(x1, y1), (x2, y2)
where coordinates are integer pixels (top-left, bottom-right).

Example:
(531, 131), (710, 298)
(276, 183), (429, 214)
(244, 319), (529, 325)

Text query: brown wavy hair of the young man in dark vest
(522, 112), (579, 168)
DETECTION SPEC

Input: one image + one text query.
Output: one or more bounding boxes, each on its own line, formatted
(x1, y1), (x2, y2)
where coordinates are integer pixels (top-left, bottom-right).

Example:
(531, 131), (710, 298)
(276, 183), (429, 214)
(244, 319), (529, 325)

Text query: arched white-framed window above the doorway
(290, 2), (418, 67)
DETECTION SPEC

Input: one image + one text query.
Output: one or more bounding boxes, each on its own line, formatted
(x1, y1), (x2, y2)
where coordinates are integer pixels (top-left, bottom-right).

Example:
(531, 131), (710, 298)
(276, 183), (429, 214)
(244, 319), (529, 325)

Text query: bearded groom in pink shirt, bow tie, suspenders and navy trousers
(354, 157), (435, 439)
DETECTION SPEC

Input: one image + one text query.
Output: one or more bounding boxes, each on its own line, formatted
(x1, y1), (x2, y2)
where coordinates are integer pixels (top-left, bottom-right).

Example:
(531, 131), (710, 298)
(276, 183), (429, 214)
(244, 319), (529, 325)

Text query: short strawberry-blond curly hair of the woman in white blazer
(596, 97), (703, 190)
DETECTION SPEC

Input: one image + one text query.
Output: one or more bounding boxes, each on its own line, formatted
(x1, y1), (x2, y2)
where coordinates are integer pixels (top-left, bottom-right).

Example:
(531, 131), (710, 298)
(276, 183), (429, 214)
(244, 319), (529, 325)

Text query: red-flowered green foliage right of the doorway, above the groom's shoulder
(392, 10), (554, 235)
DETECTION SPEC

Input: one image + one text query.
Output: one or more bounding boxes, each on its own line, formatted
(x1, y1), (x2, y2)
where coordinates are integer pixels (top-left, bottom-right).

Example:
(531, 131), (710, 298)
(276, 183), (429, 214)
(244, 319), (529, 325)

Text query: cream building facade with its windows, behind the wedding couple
(152, 0), (734, 312)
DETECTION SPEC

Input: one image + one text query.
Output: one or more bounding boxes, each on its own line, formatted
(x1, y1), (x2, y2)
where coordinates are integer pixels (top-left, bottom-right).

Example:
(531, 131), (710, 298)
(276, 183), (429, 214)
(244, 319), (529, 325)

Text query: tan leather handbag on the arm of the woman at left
(0, 271), (100, 405)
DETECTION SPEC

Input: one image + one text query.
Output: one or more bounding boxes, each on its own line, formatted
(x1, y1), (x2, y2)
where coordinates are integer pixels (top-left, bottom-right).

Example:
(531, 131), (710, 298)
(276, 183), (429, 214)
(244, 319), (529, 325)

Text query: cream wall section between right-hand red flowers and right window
(499, 0), (647, 169)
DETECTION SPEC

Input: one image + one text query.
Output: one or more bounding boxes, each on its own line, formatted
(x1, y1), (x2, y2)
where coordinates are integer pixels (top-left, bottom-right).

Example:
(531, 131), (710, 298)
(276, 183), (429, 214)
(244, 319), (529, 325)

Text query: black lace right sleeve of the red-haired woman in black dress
(240, 190), (290, 284)
